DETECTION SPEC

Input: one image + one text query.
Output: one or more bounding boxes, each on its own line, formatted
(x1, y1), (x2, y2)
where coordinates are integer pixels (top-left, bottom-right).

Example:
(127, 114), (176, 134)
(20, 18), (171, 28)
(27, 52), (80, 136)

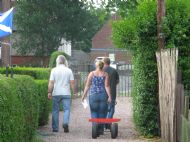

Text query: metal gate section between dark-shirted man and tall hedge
(117, 64), (133, 96)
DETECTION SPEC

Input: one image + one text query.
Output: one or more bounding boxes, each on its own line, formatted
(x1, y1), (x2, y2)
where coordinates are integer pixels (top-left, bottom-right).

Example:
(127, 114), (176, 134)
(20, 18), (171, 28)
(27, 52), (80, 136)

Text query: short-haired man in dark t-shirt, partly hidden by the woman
(103, 57), (119, 118)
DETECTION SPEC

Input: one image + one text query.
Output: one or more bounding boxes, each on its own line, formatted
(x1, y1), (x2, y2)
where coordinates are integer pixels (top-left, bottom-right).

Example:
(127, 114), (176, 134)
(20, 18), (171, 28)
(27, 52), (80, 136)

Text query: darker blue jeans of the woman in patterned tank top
(89, 93), (108, 118)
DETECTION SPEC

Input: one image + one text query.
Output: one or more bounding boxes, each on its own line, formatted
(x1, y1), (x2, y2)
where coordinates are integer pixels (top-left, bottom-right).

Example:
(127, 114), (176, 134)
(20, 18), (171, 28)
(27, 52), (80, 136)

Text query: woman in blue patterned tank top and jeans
(82, 61), (111, 134)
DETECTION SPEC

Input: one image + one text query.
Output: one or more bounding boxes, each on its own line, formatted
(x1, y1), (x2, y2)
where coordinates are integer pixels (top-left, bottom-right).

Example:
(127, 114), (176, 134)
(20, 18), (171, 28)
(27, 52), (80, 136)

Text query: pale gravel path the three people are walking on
(38, 97), (144, 142)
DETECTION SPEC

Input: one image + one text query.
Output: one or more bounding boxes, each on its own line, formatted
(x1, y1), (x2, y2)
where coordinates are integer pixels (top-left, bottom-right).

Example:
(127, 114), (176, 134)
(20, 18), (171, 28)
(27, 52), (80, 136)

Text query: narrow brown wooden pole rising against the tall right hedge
(157, 0), (166, 49)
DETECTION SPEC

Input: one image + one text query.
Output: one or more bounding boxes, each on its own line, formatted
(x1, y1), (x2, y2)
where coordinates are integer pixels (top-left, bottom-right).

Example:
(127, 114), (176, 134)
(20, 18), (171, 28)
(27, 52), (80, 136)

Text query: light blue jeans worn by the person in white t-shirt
(52, 95), (71, 130)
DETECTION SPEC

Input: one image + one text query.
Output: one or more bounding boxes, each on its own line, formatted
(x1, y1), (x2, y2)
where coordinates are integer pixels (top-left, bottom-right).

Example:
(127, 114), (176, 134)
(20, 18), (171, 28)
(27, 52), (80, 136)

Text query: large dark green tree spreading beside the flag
(15, 0), (107, 55)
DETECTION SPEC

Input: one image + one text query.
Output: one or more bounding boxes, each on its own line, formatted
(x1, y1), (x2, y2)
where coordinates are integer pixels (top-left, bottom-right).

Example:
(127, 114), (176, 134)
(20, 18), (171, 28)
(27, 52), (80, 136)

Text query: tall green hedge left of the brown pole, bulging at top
(113, 1), (159, 137)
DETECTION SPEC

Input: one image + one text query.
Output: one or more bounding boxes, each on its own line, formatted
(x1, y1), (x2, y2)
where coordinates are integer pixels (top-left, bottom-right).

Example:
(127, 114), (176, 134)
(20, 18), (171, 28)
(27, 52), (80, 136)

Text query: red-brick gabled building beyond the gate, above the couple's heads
(90, 15), (131, 64)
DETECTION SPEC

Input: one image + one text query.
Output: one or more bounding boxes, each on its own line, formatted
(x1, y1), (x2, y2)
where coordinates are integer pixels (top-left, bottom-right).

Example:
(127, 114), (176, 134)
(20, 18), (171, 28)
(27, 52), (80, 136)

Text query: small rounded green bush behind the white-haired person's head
(49, 51), (68, 68)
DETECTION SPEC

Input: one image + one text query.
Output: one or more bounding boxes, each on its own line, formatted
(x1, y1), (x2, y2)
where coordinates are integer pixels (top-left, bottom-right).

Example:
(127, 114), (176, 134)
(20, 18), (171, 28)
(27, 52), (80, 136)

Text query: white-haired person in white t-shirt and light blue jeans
(48, 55), (74, 133)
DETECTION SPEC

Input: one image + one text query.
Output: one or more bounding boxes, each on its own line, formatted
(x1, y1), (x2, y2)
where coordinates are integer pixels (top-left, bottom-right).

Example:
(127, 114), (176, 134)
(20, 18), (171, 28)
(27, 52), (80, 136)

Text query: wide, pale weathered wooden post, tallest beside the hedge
(156, 48), (178, 142)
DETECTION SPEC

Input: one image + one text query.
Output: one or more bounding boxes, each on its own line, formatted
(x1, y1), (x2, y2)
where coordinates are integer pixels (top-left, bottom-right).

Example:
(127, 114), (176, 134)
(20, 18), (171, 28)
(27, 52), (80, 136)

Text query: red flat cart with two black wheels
(89, 118), (121, 139)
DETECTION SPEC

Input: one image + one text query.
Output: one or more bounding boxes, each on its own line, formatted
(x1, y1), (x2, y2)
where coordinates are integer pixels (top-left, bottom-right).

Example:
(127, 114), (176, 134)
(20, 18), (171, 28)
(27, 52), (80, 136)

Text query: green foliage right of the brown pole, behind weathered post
(163, 0), (190, 96)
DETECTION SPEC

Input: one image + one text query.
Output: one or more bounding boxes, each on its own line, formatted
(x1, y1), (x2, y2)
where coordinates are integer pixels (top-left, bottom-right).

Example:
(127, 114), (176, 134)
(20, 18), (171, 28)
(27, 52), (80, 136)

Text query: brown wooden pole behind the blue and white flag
(1, 0), (11, 66)
